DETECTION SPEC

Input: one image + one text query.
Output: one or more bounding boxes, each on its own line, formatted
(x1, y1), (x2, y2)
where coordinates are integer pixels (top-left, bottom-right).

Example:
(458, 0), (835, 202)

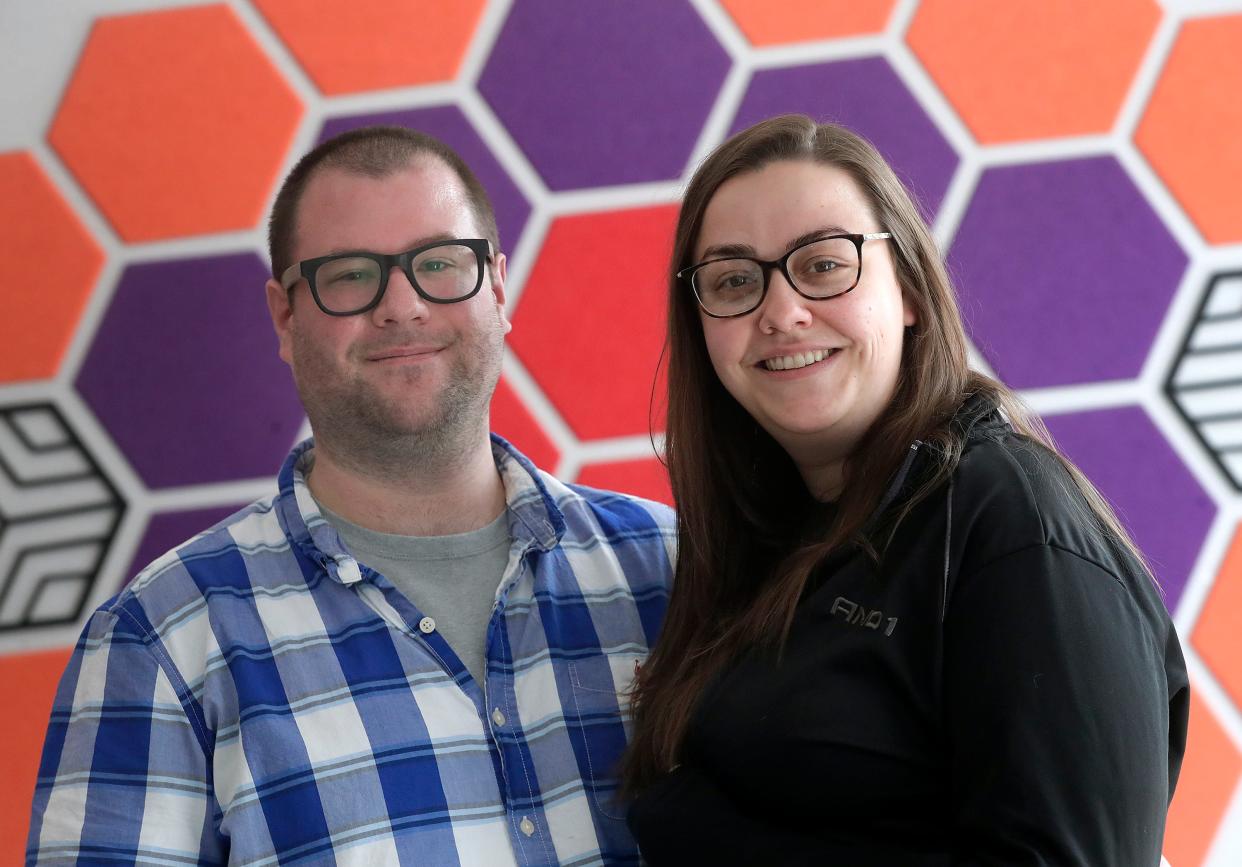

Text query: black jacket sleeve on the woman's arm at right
(943, 545), (1170, 867)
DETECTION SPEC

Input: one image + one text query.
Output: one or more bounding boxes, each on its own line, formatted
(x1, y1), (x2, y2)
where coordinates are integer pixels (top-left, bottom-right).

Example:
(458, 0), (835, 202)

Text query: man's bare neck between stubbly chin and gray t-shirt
(307, 438), (504, 535)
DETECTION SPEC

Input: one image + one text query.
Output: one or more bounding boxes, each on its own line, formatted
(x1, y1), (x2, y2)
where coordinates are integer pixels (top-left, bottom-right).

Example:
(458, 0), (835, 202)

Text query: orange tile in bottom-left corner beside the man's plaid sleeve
(0, 647), (72, 865)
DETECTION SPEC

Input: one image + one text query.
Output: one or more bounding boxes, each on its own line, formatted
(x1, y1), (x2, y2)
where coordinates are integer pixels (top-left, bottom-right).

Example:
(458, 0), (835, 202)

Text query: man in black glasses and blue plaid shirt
(27, 127), (674, 867)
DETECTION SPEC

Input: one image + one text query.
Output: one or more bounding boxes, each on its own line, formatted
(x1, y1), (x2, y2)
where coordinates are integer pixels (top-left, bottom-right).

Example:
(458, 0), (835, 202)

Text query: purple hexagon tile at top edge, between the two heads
(478, 0), (730, 190)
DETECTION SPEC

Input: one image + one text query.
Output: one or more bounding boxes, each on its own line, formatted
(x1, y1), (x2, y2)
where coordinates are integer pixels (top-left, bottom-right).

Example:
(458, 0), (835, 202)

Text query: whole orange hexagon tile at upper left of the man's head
(48, 5), (302, 241)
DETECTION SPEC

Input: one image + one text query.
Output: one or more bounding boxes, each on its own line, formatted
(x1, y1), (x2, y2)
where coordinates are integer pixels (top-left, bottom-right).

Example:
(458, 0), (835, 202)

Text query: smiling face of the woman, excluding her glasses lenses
(694, 160), (915, 476)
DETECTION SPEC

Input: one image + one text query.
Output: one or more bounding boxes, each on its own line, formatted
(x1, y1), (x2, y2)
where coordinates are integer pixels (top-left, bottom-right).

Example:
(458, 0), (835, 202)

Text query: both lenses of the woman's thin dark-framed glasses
(693, 237), (858, 315)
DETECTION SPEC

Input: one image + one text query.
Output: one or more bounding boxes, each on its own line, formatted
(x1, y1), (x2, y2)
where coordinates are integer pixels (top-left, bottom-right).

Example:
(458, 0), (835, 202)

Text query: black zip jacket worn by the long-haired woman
(630, 405), (1189, 867)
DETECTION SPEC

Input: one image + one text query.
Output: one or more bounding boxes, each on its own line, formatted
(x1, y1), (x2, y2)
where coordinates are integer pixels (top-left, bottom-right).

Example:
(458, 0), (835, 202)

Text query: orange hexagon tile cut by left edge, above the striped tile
(0, 152), (103, 383)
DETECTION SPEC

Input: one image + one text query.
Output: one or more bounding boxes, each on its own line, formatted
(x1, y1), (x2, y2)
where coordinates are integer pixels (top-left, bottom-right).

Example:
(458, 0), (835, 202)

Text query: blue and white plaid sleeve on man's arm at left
(26, 603), (227, 867)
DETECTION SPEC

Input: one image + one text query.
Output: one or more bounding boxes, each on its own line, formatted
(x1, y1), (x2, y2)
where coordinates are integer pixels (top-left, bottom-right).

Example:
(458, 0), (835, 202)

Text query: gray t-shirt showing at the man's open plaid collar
(319, 503), (509, 686)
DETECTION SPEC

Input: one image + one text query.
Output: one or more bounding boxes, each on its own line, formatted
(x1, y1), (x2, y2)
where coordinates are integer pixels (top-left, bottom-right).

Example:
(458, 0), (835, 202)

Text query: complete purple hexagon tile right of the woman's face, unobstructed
(949, 157), (1186, 388)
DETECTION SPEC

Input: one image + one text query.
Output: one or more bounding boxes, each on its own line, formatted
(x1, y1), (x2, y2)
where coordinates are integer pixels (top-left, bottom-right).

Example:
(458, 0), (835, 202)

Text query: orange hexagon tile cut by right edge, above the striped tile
(1135, 15), (1242, 243)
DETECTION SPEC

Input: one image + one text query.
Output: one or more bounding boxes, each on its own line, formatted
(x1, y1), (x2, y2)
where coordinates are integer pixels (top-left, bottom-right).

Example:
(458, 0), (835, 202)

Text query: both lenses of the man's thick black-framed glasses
(314, 243), (479, 313)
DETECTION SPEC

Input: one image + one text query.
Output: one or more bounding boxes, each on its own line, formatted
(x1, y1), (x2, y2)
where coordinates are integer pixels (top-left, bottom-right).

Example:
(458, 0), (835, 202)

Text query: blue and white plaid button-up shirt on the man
(27, 437), (676, 867)
